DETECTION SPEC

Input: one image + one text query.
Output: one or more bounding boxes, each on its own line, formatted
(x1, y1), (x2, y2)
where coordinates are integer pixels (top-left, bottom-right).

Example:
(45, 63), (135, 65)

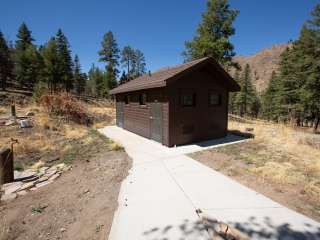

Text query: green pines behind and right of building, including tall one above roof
(183, 0), (320, 130)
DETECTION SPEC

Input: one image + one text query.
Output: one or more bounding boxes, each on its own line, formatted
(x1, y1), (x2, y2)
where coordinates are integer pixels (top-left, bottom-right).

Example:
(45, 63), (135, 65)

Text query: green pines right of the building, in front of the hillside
(230, 4), (320, 130)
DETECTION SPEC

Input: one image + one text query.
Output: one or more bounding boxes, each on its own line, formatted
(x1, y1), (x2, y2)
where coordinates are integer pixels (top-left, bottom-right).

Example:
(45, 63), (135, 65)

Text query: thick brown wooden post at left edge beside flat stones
(0, 148), (14, 185)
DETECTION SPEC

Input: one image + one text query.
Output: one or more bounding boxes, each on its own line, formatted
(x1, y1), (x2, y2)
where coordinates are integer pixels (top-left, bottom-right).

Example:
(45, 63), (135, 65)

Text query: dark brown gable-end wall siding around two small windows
(169, 65), (228, 146)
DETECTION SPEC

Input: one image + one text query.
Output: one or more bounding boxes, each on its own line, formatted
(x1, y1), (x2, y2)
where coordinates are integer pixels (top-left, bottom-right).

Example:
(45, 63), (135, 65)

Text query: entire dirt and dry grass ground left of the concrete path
(0, 92), (131, 240)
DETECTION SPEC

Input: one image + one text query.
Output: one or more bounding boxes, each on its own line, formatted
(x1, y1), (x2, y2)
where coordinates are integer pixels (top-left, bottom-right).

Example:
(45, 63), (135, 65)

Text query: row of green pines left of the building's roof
(0, 23), (146, 97)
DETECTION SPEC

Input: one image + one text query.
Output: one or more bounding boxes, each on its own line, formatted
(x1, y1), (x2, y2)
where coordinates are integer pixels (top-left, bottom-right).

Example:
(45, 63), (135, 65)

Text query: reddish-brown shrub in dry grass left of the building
(40, 93), (92, 125)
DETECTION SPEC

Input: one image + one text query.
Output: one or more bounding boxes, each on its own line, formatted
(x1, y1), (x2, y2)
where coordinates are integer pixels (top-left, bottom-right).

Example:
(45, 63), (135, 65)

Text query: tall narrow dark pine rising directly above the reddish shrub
(56, 29), (73, 92)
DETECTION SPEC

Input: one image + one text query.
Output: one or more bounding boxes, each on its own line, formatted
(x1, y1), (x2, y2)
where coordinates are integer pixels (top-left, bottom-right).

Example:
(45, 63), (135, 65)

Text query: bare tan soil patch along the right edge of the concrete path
(191, 140), (320, 221)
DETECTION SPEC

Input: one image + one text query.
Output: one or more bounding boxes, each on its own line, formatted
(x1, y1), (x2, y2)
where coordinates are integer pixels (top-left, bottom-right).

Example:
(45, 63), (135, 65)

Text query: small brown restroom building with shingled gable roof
(110, 58), (240, 147)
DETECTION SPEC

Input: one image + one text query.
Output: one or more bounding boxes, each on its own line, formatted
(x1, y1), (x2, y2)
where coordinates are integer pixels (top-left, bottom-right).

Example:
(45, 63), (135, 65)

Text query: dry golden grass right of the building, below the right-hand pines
(229, 120), (320, 196)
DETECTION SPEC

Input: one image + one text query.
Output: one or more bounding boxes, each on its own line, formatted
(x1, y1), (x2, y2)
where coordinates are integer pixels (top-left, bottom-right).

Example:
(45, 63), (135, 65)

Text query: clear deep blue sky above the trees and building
(0, 0), (320, 71)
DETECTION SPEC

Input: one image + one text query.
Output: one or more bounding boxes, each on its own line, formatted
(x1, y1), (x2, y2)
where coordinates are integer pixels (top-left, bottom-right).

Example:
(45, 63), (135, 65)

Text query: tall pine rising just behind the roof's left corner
(99, 31), (120, 91)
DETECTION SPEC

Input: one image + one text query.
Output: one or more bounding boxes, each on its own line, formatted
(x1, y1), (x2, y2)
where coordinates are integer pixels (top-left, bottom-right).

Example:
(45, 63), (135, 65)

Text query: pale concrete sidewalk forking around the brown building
(100, 126), (320, 240)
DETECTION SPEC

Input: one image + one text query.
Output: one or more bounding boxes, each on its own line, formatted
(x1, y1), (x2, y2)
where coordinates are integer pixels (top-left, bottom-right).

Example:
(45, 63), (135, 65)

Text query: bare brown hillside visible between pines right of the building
(234, 44), (288, 92)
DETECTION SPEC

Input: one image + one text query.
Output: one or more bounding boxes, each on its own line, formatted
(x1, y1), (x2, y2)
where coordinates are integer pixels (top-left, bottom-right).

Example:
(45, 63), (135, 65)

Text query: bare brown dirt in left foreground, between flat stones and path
(0, 147), (131, 240)
